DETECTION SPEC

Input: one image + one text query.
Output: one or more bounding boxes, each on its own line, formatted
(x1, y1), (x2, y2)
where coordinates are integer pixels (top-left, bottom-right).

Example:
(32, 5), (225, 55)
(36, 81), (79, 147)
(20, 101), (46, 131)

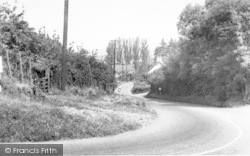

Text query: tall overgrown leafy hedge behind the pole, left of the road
(0, 4), (115, 91)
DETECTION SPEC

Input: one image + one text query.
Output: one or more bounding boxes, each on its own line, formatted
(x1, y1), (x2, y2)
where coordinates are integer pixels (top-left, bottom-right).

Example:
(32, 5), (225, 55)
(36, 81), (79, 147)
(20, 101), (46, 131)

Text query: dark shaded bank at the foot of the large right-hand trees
(146, 93), (248, 107)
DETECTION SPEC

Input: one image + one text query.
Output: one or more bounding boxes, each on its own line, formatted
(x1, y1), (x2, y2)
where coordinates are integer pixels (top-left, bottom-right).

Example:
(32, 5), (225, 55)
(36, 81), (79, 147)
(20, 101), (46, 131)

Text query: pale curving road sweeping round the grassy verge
(21, 83), (250, 155)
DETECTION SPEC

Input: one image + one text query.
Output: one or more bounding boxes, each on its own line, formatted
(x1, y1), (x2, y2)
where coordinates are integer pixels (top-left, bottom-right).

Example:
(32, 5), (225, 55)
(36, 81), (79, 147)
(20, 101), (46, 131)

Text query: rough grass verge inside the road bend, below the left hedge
(0, 90), (156, 142)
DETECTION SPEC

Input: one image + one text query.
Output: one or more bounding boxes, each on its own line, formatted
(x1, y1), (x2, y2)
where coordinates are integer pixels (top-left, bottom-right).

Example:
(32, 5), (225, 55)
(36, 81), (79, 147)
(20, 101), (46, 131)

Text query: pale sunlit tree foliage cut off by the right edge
(231, 0), (250, 102)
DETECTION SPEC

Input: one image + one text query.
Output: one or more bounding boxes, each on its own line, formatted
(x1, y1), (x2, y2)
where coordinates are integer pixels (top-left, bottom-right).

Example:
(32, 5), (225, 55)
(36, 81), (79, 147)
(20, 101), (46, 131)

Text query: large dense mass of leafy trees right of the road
(150, 0), (250, 106)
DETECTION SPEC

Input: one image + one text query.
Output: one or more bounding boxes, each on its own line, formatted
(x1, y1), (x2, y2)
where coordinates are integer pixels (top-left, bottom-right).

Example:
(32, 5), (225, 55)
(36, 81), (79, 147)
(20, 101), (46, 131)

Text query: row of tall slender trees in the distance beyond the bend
(105, 37), (150, 80)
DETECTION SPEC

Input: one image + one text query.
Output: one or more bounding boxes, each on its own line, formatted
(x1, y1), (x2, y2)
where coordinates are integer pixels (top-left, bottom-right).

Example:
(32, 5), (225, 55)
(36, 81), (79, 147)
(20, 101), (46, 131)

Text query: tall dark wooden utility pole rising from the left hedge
(61, 0), (69, 91)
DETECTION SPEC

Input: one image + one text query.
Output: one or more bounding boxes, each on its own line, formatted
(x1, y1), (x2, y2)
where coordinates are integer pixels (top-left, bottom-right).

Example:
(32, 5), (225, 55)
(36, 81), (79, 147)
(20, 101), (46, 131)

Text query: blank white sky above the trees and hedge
(0, 0), (205, 55)
